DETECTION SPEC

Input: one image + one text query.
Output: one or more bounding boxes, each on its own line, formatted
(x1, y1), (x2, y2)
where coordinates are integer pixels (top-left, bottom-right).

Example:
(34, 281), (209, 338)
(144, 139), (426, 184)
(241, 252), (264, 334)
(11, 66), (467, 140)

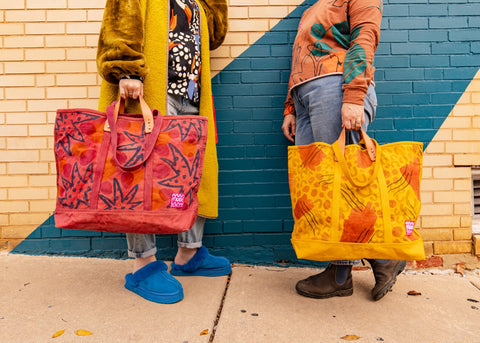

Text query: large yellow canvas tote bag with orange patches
(288, 130), (425, 261)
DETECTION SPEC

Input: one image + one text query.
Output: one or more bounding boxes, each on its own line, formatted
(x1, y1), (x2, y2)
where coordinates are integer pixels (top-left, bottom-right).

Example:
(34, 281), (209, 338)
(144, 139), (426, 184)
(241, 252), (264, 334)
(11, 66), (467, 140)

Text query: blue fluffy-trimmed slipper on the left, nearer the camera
(125, 261), (183, 304)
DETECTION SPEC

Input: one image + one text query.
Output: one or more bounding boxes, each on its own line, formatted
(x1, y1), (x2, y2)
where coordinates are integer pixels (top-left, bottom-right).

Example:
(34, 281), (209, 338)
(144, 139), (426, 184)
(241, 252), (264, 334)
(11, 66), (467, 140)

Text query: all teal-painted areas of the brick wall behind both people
(15, 0), (480, 264)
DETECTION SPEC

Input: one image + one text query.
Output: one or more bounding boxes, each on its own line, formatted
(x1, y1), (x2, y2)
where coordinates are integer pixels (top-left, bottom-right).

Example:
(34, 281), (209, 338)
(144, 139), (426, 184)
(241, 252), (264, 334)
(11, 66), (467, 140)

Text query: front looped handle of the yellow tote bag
(332, 129), (380, 187)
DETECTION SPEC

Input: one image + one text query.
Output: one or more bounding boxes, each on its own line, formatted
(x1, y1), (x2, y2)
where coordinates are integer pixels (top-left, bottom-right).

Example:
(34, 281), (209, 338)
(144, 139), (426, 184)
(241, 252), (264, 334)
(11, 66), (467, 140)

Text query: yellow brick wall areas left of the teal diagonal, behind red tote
(0, 0), (301, 250)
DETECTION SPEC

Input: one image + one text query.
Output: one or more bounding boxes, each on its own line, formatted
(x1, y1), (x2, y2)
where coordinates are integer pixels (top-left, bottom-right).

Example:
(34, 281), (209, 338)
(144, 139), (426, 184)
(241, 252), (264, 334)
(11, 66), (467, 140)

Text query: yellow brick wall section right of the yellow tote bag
(418, 71), (480, 254)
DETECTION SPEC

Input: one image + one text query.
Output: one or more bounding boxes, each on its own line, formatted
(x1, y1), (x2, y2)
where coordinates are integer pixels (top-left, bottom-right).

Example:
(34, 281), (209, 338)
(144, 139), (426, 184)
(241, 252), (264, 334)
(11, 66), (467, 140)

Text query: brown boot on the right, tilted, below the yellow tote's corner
(367, 260), (407, 301)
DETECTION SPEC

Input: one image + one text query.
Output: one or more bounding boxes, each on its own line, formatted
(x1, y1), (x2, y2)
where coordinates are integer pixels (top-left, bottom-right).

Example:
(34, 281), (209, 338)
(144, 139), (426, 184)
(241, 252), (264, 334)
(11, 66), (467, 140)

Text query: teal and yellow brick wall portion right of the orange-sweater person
(372, 0), (480, 255)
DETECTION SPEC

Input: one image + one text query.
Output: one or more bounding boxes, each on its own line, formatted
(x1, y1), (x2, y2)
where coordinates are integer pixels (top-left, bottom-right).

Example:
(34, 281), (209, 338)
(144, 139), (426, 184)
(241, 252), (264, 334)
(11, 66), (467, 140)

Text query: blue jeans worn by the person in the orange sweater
(292, 75), (377, 265)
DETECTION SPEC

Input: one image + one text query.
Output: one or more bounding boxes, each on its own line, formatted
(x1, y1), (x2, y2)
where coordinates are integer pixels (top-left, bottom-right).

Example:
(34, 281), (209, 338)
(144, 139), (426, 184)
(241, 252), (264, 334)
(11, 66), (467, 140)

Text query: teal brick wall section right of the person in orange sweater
(370, 0), (480, 146)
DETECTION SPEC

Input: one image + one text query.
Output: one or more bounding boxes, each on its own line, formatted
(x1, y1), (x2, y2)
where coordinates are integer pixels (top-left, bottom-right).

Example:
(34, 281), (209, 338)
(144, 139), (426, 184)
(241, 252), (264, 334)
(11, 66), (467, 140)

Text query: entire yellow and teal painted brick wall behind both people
(0, 0), (480, 262)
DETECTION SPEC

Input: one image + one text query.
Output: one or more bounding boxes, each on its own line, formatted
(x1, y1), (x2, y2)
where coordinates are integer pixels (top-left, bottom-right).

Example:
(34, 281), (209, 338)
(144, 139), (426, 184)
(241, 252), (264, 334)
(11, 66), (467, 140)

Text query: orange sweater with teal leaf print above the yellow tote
(284, 0), (383, 115)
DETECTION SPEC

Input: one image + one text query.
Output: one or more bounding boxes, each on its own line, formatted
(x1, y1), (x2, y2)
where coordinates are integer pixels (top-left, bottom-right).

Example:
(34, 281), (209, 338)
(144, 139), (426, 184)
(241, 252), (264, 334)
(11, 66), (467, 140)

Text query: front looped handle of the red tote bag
(107, 97), (162, 170)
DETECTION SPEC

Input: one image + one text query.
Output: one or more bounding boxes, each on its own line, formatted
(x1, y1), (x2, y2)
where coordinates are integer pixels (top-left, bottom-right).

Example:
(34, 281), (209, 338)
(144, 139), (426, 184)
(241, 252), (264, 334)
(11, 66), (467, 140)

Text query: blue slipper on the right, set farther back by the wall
(170, 246), (232, 276)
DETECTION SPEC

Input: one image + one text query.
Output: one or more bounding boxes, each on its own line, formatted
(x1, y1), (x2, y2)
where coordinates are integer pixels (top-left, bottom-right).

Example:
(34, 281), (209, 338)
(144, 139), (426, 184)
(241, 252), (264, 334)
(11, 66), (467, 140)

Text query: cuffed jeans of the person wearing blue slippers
(126, 94), (205, 258)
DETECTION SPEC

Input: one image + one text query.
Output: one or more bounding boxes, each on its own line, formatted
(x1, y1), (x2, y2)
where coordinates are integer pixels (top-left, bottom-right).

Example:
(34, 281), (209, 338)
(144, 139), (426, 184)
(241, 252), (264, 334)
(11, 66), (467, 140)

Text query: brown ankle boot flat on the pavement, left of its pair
(295, 264), (353, 299)
